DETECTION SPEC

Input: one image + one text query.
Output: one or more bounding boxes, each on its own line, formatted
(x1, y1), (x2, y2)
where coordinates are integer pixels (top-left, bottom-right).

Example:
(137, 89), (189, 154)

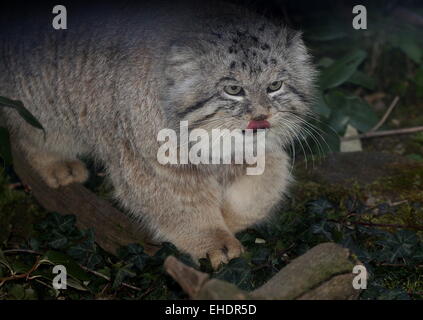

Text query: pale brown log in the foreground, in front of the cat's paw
(164, 243), (360, 300)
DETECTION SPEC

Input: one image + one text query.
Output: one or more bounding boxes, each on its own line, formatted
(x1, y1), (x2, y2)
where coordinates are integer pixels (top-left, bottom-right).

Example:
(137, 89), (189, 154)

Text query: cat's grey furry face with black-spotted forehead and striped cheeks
(163, 21), (315, 150)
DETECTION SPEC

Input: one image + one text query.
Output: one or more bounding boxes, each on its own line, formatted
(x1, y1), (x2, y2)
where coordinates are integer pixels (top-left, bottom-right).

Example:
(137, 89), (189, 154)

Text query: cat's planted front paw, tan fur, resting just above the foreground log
(191, 230), (244, 270)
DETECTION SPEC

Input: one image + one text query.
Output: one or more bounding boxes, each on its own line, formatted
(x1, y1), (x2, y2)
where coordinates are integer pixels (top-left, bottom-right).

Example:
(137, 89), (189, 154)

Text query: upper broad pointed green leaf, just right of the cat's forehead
(320, 50), (367, 90)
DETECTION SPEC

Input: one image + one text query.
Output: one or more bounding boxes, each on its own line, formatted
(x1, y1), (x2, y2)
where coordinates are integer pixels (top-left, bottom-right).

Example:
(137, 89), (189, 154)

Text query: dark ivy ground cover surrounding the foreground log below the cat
(0, 189), (423, 299)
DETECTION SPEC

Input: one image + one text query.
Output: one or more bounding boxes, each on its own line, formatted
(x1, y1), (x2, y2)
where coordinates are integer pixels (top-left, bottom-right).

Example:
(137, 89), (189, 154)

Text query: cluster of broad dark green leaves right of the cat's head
(302, 7), (423, 152)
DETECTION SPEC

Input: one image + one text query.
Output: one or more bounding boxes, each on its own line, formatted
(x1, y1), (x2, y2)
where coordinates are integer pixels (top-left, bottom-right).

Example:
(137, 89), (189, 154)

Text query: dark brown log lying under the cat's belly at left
(12, 147), (158, 254)
